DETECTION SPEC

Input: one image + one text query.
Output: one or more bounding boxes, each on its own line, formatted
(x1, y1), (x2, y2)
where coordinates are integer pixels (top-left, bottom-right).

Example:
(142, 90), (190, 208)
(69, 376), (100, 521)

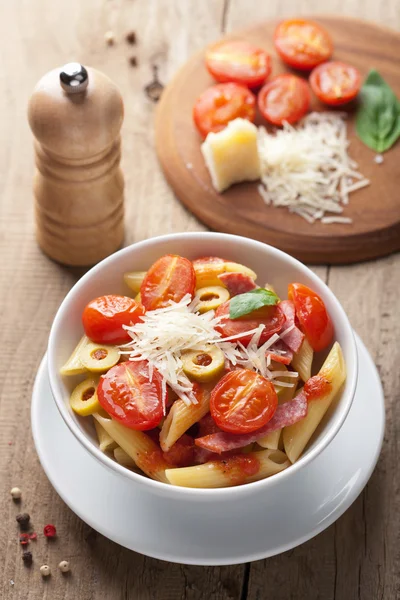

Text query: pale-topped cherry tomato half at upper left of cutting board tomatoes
(206, 40), (271, 88)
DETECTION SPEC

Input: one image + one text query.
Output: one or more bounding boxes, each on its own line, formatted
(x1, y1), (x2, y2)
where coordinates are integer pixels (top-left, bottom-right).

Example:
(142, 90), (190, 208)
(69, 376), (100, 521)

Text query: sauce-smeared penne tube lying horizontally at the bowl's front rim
(165, 450), (290, 488)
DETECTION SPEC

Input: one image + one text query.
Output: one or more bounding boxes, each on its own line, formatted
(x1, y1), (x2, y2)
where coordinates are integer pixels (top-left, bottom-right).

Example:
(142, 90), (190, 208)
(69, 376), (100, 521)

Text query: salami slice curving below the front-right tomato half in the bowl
(194, 391), (308, 454)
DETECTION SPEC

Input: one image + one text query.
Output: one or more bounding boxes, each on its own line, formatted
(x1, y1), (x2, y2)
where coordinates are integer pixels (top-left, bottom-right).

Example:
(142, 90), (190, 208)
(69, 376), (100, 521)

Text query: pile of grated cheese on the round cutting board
(258, 112), (370, 224)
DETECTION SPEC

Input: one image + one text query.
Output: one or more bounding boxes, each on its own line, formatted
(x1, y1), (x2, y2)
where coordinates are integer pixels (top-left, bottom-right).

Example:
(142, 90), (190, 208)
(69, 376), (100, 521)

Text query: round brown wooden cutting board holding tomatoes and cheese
(155, 17), (400, 264)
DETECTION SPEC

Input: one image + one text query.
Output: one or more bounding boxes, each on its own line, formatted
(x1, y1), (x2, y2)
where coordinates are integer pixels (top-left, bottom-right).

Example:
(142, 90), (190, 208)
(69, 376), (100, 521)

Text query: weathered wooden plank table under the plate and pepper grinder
(0, 0), (400, 600)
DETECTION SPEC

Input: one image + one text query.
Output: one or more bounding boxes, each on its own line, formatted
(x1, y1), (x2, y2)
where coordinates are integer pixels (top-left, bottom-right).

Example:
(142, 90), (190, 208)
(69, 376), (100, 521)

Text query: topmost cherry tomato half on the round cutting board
(274, 19), (333, 71)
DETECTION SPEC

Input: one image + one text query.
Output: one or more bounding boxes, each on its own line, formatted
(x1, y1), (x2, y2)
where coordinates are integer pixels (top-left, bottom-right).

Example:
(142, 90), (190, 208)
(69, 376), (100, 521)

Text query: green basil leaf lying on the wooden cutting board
(356, 69), (400, 152)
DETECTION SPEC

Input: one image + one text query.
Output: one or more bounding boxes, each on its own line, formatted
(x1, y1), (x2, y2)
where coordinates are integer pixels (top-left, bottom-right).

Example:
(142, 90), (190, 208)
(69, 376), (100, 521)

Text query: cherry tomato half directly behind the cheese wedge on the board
(193, 83), (256, 137)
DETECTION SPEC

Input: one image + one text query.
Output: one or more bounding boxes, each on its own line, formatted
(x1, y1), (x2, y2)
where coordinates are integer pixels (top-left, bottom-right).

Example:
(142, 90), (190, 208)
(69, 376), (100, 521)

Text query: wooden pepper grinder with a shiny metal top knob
(28, 63), (124, 266)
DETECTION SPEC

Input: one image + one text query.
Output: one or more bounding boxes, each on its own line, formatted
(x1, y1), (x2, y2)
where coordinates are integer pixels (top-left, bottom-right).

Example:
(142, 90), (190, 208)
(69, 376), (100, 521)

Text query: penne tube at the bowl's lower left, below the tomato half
(93, 413), (170, 483)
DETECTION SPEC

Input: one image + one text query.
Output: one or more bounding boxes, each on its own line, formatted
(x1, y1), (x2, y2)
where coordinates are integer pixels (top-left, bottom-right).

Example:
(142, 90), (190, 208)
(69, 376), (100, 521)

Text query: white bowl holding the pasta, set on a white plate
(48, 233), (357, 502)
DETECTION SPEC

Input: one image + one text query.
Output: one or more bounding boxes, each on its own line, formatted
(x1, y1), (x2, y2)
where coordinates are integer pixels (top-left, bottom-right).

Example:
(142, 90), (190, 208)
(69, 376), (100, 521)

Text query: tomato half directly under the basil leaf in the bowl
(215, 300), (285, 346)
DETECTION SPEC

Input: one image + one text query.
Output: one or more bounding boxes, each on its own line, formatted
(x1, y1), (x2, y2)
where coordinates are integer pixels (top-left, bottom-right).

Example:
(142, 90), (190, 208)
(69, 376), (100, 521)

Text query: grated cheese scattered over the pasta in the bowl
(121, 294), (297, 405)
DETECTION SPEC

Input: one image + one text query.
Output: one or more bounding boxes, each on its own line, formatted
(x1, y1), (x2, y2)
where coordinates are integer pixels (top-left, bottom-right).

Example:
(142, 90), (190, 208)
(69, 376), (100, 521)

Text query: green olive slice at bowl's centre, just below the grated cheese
(182, 346), (225, 382)
